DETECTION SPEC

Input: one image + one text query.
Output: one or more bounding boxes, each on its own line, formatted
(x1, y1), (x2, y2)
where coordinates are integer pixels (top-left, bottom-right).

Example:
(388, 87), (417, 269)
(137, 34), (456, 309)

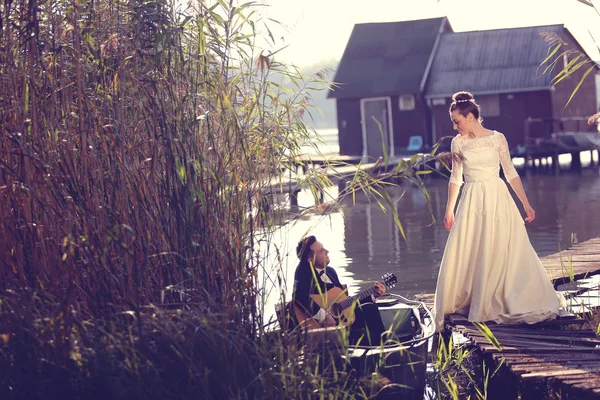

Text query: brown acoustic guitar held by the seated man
(294, 273), (398, 329)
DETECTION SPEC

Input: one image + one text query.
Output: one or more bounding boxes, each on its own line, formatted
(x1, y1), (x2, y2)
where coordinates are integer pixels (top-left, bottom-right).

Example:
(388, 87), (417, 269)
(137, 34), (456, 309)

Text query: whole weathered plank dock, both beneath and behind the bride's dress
(417, 237), (600, 399)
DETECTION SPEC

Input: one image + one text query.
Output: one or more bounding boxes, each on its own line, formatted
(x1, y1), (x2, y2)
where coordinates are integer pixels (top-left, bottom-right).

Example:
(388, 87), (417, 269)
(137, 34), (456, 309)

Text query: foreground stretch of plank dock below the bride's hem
(446, 315), (600, 399)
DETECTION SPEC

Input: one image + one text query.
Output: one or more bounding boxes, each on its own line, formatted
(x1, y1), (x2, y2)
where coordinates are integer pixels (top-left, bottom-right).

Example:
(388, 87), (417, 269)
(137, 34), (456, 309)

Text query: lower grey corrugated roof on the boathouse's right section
(425, 25), (567, 97)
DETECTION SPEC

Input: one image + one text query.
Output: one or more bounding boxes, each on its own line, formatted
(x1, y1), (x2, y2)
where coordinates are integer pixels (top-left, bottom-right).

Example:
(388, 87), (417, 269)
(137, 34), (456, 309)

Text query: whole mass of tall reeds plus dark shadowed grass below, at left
(0, 0), (440, 399)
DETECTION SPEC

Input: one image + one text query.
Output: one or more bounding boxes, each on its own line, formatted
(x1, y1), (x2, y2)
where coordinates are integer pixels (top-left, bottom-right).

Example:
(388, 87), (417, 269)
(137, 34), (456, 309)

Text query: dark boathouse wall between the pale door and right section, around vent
(391, 94), (431, 152)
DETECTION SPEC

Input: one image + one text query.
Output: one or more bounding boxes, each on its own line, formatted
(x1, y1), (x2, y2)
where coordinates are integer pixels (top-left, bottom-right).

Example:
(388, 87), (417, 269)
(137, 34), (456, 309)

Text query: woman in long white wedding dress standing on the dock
(435, 92), (564, 330)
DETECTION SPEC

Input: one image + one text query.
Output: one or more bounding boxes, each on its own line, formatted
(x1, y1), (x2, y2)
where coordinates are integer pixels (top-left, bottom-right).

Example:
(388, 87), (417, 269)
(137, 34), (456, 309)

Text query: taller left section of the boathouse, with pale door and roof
(328, 18), (452, 157)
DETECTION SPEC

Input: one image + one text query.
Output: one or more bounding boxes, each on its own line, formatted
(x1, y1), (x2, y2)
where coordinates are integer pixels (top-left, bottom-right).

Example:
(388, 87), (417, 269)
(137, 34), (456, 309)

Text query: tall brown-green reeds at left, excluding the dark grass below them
(0, 0), (324, 328)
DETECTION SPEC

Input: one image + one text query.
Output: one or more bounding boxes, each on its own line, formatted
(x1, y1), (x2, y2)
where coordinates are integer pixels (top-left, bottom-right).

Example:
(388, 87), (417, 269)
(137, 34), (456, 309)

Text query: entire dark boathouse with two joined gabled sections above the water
(328, 18), (600, 157)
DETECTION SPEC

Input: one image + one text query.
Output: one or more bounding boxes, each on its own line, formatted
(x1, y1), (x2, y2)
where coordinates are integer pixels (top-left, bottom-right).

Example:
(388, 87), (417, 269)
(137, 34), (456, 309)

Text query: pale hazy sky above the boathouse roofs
(261, 0), (600, 66)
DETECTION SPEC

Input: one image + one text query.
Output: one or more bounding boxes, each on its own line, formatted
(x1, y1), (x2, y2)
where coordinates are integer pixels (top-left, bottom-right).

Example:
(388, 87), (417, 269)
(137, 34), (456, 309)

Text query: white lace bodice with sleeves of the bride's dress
(450, 131), (519, 186)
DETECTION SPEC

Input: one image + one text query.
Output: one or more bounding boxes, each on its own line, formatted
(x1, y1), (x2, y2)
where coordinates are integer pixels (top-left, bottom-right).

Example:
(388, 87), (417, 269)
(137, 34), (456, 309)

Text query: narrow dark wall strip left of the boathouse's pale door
(336, 99), (363, 156)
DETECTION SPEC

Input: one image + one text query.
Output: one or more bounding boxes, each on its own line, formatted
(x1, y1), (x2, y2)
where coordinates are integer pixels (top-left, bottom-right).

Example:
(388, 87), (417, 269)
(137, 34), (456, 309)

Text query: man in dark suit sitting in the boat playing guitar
(293, 236), (386, 345)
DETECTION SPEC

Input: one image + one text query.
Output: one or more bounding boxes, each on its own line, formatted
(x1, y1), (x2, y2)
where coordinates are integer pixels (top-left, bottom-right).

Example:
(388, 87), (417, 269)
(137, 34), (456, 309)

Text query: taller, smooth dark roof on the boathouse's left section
(327, 18), (447, 99)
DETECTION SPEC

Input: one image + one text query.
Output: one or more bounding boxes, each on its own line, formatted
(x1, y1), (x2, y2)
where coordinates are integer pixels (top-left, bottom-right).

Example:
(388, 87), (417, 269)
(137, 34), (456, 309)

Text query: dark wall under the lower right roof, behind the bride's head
(433, 91), (552, 148)
